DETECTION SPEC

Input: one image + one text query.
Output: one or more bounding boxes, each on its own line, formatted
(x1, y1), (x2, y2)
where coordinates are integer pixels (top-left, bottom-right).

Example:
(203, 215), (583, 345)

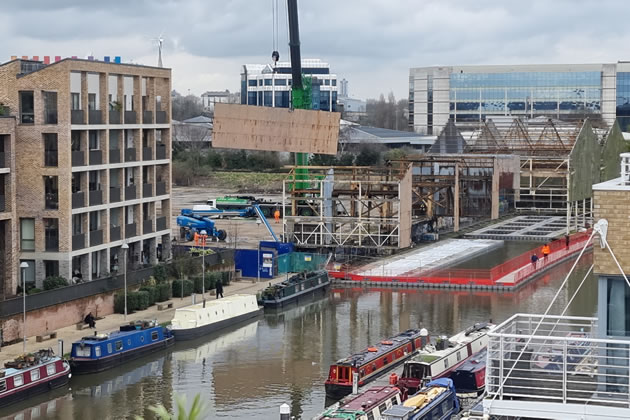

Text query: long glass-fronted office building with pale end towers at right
(409, 62), (630, 134)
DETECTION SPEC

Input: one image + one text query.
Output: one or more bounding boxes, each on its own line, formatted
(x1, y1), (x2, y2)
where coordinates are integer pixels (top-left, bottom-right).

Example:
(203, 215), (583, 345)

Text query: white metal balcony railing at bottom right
(484, 314), (630, 415)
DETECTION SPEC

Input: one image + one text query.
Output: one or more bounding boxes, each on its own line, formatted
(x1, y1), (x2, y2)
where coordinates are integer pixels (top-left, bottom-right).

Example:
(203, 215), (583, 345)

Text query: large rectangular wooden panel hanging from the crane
(212, 104), (340, 155)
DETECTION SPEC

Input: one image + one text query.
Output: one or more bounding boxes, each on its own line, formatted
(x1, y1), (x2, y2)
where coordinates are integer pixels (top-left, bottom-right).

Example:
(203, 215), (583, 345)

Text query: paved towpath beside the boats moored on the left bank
(0, 275), (286, 363)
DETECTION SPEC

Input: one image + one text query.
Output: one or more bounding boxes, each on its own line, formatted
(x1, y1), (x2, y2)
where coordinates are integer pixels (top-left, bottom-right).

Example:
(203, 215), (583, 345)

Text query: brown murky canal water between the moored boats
(0, 251), (597, 420)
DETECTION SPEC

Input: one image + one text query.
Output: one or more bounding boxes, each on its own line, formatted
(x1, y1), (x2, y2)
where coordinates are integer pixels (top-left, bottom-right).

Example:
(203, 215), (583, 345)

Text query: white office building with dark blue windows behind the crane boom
(241, 59), (337, 111)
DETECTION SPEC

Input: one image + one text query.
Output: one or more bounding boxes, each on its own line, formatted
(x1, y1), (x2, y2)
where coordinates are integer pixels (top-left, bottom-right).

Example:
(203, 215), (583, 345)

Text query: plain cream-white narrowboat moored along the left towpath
(171, 295), (263, 341)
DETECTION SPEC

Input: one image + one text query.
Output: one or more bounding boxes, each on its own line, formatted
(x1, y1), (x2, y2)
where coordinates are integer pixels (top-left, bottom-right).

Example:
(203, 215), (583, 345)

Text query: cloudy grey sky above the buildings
(0, 0), (630, 99)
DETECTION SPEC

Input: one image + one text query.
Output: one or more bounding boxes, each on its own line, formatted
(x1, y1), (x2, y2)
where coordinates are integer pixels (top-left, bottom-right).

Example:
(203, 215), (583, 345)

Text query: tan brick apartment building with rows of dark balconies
(0, 59), (171, 299)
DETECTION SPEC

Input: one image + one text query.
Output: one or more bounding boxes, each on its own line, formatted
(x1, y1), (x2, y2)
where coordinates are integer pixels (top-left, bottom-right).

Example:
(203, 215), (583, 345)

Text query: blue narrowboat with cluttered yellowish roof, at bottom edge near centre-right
(382, 378), (460, 420)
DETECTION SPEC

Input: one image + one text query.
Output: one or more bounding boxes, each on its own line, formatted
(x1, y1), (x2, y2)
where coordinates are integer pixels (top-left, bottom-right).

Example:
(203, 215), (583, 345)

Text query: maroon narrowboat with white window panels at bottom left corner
(0, 349), (70, 407)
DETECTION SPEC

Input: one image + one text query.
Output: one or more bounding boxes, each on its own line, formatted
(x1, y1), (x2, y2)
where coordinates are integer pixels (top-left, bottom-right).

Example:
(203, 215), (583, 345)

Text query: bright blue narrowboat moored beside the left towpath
(70, 321), (175, 374)
